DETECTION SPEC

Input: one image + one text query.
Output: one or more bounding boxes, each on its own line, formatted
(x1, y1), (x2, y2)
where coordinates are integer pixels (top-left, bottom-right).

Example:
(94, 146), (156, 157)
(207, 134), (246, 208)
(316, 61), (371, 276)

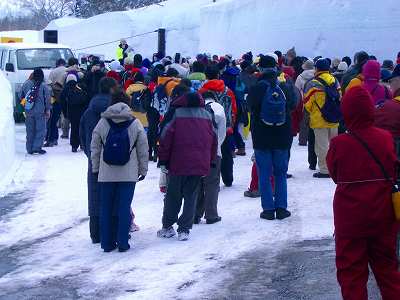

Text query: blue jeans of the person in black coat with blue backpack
(255, 149), (289, 210)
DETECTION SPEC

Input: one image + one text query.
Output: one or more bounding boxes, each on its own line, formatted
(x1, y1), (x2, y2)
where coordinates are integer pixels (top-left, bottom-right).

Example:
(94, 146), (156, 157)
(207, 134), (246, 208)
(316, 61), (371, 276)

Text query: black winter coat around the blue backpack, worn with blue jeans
(247, 76), (297, 151)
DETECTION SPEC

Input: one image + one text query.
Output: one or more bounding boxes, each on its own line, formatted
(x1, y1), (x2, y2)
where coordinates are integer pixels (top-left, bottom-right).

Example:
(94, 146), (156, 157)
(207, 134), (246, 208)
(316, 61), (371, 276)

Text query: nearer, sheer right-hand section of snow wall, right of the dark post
(200, 0), (400, 59)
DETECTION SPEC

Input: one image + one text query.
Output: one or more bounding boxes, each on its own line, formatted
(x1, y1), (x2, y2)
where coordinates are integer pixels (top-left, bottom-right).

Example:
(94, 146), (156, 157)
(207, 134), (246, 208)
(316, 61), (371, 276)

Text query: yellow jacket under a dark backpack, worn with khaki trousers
(304, 72), (340, 128)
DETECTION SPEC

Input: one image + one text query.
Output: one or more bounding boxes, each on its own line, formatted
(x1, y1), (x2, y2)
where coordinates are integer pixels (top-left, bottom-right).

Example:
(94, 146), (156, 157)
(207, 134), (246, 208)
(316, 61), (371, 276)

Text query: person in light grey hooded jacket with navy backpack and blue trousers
(90, 90), (148, 252)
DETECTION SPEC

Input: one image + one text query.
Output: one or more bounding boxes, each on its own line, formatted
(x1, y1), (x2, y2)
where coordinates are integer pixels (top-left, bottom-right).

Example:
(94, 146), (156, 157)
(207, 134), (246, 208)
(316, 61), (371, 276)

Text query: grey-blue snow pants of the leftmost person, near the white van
(25, 113), (46, 153)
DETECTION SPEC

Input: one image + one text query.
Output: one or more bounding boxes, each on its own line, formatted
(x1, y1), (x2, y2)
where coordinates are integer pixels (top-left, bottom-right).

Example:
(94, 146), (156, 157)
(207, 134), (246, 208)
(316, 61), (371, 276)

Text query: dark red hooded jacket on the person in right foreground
(327, 87), (397, 238)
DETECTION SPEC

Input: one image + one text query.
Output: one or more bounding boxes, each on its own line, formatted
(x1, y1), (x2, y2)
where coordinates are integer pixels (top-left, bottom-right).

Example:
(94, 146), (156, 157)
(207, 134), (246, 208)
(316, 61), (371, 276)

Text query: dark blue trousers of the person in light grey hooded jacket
(100, 182), (135, 250)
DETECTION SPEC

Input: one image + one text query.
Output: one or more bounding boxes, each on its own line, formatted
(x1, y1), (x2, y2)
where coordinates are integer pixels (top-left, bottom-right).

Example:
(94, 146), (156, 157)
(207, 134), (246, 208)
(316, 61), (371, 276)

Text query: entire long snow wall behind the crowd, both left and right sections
(29, 0), (400, 60)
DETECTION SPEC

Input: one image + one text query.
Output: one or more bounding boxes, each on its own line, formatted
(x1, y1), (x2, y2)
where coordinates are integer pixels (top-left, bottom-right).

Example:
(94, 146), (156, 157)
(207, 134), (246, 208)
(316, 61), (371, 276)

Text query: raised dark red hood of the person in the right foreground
(341, 86), (374, 131)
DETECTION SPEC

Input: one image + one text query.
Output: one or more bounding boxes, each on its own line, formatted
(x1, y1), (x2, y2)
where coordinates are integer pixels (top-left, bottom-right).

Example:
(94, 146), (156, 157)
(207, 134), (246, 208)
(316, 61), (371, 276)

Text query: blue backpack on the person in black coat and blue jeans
(260, 81), (286, 126)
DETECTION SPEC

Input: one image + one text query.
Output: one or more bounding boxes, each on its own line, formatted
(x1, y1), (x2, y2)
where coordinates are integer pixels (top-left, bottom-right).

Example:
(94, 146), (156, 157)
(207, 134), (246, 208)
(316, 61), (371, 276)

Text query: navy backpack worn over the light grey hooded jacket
(103, 119), (137, 166)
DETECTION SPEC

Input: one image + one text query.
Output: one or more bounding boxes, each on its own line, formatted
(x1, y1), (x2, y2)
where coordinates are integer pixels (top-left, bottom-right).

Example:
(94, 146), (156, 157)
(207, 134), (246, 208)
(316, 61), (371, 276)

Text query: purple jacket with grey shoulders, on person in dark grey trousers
(158, 93), (218, 176)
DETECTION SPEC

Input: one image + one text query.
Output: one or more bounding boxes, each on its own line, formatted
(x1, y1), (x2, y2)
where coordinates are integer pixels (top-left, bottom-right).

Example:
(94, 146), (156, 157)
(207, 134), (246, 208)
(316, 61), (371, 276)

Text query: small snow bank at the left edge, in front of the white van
(0, 72), (15, 192)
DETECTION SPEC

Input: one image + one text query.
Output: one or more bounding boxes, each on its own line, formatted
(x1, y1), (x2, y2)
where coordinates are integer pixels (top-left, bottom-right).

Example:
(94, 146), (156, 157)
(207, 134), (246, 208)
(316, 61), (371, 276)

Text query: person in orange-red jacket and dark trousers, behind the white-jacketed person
(199, 65), (237, 187)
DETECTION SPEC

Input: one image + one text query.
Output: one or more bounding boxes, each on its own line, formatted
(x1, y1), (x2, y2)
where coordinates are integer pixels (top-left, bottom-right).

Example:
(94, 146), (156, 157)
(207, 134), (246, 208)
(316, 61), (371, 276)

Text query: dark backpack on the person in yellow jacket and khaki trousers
(316, 78), (342, 123)
